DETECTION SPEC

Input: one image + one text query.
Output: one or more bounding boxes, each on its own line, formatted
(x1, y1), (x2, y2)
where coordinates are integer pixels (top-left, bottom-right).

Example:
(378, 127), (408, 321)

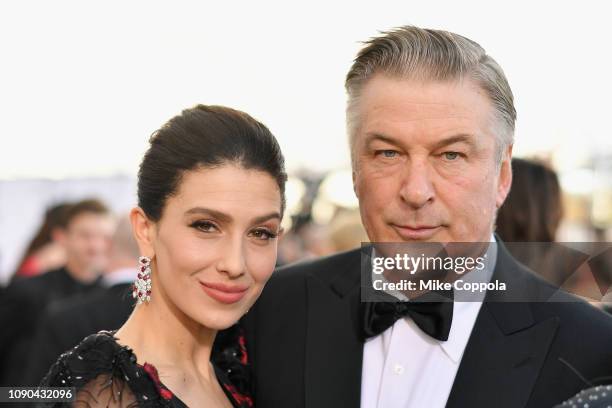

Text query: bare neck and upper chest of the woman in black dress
(116, 286), (217, 380)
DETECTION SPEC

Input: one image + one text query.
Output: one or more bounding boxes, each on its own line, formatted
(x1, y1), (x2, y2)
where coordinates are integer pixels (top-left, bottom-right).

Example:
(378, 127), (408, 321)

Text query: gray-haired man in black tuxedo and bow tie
(243, 27), (612, 408)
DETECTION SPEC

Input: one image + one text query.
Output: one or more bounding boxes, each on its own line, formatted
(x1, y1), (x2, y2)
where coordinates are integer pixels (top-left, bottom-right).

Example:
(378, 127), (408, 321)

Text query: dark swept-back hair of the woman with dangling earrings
(138, 105), (287, 221)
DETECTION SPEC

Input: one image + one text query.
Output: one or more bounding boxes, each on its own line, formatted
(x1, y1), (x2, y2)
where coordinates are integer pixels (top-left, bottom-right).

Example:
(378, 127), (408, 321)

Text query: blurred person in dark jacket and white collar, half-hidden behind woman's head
(23, 216), (139, 386)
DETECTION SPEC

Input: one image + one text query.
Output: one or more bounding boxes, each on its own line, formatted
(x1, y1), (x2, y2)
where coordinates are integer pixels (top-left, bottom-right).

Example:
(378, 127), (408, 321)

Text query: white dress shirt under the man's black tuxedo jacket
(361, 236), (497, 408)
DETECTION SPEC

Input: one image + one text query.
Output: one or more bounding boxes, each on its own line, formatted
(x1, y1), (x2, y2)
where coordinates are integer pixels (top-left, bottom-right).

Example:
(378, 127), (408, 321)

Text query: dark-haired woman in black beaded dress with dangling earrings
(41, 105), (286, 407)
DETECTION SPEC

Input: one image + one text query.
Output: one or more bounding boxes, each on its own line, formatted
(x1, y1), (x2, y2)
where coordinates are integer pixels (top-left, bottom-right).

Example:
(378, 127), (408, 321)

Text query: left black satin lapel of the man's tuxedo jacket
(305, 251), (363, 408)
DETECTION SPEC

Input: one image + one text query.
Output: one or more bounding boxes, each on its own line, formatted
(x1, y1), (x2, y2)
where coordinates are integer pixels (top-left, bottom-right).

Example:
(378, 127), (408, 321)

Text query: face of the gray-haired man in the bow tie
(353, 75), (512, 242)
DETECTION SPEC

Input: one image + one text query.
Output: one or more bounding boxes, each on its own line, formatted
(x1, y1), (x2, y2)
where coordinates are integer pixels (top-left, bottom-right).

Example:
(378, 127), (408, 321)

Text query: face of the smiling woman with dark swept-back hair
(135, 164), (281, 330)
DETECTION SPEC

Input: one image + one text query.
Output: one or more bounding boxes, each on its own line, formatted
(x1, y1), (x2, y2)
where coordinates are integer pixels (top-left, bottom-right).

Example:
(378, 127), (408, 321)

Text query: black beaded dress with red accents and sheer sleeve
(39, 331), (253, 408)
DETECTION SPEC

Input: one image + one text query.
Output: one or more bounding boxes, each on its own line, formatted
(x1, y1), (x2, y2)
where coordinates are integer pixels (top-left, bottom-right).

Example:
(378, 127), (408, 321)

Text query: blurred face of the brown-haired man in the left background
(64, 212), (114, 271)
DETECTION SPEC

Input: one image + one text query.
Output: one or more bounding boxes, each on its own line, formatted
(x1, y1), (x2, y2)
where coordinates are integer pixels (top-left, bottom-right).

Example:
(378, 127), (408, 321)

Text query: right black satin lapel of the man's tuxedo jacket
(446, 240), (559, 408)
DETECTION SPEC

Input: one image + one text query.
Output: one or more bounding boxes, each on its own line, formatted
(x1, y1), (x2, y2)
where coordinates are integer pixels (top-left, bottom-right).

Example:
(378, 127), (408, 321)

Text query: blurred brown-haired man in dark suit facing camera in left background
(0, 199), (114, 386)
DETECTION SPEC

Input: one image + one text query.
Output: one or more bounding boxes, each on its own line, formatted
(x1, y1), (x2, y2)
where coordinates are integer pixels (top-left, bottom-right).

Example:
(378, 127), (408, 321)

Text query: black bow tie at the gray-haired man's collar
(362, 291), (453, 341)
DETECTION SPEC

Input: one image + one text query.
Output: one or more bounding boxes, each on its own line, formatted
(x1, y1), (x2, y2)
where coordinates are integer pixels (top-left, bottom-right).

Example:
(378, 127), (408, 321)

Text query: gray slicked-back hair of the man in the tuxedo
(345, 26), (516, 165)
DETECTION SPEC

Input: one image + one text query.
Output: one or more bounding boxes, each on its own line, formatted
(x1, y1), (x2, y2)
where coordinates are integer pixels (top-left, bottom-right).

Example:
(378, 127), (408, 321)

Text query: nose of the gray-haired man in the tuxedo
(399, 159), (435, 209)
